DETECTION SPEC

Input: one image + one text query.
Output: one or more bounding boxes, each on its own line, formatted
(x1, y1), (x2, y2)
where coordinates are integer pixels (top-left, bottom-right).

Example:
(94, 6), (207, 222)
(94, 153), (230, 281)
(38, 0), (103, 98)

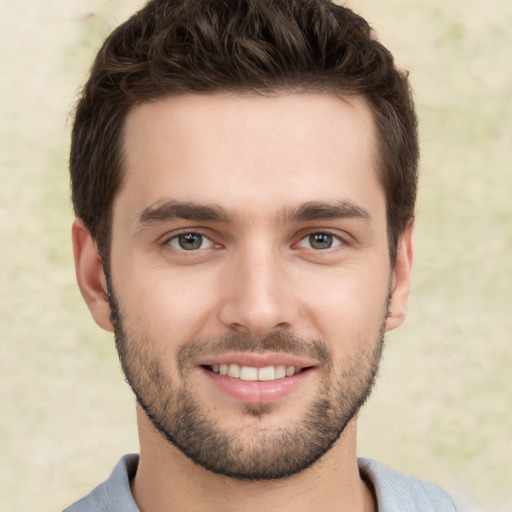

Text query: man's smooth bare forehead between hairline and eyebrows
(118, 93), (383, 226)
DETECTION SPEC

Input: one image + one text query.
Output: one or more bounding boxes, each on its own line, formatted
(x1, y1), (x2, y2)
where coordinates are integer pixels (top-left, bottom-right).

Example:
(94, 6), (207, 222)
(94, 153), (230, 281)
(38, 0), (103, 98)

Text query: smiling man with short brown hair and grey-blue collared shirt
(66, 0), (455, 512)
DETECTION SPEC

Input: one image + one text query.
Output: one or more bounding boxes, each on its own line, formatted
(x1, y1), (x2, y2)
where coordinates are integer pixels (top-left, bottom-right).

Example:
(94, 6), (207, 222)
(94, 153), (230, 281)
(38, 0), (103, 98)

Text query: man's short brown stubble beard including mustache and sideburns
(109, 286), (389, 481)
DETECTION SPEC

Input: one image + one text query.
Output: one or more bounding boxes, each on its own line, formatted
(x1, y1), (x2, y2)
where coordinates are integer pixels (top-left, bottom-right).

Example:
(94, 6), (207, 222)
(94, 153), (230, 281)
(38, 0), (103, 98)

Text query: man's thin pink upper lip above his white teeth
(198, 352), (318, 368)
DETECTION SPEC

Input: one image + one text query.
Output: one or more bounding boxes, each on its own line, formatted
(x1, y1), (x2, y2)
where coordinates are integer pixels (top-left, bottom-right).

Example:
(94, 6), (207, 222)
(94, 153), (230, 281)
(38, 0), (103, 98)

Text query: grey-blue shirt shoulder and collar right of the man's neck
(358, 458), (456, 512)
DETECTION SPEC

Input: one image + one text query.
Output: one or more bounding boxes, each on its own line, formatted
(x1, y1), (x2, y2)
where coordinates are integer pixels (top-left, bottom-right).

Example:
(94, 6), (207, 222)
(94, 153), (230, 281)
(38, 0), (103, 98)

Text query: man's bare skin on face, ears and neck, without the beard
(73, 93), (412, 512)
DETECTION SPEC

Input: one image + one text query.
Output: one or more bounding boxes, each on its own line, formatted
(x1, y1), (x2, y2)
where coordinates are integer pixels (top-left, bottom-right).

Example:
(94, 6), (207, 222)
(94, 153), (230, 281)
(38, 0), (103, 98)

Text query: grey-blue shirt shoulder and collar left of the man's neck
(63, 454), (139, 512)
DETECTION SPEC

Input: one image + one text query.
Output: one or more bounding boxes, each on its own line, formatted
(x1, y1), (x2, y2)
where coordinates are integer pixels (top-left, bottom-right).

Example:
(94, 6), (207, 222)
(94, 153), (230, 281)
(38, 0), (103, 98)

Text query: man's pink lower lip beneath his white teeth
(200, 368), (314, 404)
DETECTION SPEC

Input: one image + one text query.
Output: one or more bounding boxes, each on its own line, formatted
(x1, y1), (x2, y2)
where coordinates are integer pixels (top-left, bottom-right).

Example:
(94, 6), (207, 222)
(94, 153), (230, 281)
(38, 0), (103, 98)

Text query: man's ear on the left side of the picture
(71, 219), (114, 332)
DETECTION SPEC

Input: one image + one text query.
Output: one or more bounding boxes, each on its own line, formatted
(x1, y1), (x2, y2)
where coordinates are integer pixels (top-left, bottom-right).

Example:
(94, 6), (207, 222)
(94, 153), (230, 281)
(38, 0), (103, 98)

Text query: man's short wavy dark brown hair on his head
(70, 0), (419, 266)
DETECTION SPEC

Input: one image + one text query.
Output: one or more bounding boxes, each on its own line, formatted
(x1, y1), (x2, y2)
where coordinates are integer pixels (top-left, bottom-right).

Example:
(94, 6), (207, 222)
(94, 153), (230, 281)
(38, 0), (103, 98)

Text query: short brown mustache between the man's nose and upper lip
(177, 331), (333, 368)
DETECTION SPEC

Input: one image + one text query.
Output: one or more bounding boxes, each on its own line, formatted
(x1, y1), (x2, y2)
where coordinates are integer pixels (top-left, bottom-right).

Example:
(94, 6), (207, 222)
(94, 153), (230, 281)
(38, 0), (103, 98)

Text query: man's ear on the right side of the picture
(386, 221), (414, 331)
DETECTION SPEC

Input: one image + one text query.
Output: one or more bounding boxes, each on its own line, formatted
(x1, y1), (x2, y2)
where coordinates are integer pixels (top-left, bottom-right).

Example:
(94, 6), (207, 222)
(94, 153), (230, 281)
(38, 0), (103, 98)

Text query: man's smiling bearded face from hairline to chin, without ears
(92, 94), (412, 478)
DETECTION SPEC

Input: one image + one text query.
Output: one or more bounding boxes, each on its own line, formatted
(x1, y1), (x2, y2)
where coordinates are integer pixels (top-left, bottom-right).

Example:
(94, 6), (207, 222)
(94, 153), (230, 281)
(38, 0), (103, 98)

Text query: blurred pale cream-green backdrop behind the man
(0, 0), (512, 512)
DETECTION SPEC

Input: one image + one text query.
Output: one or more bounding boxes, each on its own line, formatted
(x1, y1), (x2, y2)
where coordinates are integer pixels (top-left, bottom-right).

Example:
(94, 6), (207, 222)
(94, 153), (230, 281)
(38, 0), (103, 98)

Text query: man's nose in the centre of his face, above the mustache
(219, 246), (298, 337)
